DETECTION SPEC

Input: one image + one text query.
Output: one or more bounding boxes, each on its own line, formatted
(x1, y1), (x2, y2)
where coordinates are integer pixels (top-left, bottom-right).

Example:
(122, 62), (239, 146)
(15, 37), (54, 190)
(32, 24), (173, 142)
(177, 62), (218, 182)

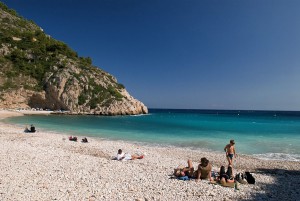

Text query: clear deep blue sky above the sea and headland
(0, 0), (300, 111)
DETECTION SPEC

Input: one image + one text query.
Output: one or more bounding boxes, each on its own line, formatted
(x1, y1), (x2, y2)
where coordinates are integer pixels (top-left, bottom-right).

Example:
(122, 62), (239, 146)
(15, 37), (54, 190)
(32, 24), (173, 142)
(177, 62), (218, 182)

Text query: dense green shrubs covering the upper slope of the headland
(0, 2), (84, 87)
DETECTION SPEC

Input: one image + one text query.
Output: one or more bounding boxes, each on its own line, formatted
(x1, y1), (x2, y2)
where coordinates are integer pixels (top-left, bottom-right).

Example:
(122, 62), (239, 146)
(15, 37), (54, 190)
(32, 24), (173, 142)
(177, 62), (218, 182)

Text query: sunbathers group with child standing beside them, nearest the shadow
(174, 140), (236, 187)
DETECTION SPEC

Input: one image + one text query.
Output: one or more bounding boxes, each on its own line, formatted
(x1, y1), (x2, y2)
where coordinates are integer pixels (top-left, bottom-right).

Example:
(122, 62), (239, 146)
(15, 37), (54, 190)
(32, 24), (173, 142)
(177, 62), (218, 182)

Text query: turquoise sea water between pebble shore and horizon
(4, 109), (300, 161)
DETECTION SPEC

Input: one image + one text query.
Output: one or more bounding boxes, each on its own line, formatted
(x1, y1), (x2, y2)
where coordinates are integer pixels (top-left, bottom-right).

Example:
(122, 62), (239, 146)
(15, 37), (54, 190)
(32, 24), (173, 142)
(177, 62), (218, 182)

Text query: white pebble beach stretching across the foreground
(0, 111), (300, 201)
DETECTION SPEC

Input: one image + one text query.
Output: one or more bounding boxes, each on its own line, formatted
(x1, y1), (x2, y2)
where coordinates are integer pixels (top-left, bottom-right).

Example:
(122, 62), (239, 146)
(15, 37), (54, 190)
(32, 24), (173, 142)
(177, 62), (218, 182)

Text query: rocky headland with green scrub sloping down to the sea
(0, 3), (148, 115)
